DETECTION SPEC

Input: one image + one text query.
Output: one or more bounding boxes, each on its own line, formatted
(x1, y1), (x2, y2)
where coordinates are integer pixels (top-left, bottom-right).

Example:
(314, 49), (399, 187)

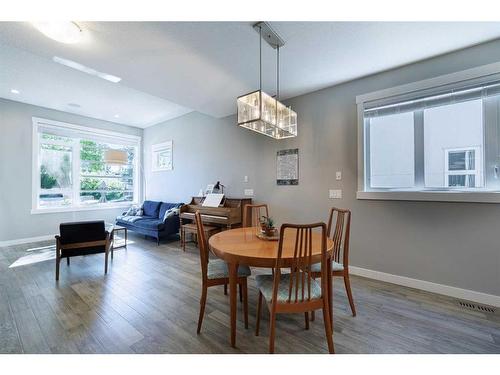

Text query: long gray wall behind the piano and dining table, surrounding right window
(144, 37), (500, 295)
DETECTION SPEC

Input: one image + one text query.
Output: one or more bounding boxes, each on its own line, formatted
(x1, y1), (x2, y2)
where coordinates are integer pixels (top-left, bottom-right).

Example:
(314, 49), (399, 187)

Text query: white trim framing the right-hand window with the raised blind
(356, 63), (500, 203)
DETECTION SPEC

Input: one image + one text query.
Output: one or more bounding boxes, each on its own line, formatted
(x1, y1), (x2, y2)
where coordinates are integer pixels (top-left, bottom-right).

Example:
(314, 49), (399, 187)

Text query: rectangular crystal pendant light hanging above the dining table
(237, 22), (297, 139)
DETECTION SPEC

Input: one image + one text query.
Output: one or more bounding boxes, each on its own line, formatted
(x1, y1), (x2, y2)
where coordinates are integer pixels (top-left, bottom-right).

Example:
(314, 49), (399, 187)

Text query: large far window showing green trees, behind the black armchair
(33, 118), (140, 212)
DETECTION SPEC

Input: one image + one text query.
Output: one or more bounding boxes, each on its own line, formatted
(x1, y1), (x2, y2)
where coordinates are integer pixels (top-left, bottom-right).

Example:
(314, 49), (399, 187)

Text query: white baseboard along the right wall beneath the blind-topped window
(349, 266), (500, 307)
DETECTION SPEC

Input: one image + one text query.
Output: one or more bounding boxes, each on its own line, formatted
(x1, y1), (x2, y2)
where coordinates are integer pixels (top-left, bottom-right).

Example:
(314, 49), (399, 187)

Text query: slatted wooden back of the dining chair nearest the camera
(272, 223), (327, 303)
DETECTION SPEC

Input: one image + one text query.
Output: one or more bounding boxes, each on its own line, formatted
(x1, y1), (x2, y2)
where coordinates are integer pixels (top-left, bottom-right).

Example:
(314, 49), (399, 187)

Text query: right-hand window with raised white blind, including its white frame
(357, 64), (500, 202)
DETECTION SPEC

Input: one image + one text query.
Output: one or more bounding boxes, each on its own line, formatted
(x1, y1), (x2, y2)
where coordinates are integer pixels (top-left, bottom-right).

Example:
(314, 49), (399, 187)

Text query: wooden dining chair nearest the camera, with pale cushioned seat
(255, 223), (334, 353)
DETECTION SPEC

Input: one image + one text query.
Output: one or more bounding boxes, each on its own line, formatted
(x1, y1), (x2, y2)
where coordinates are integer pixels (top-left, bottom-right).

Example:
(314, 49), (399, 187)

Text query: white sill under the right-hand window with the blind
(356, 191), (500, 203)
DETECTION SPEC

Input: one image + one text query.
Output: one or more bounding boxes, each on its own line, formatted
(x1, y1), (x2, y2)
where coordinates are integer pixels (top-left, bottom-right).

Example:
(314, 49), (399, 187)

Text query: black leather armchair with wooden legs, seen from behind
(56, 221), (113, 280)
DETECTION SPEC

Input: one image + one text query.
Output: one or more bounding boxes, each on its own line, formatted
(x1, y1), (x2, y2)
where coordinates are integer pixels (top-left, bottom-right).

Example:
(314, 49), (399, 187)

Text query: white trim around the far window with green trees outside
(31, 117), (143, 215)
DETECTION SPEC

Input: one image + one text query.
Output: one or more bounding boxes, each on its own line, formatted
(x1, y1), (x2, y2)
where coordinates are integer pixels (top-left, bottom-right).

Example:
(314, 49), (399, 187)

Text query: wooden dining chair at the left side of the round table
(194, 211), (251, 333)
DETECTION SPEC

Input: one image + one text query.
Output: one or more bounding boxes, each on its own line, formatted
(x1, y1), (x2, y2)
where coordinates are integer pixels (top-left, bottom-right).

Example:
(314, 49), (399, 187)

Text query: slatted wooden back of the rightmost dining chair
(327, 207), (351, 269)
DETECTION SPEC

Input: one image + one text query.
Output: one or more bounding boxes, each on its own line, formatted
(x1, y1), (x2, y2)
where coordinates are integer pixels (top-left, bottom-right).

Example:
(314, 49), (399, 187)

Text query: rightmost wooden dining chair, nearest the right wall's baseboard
(311, 207), (356, 320)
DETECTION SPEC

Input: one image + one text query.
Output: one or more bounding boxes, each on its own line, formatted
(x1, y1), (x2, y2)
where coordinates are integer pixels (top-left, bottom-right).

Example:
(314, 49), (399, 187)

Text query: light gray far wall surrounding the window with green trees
(0, 99), (142, 241)
